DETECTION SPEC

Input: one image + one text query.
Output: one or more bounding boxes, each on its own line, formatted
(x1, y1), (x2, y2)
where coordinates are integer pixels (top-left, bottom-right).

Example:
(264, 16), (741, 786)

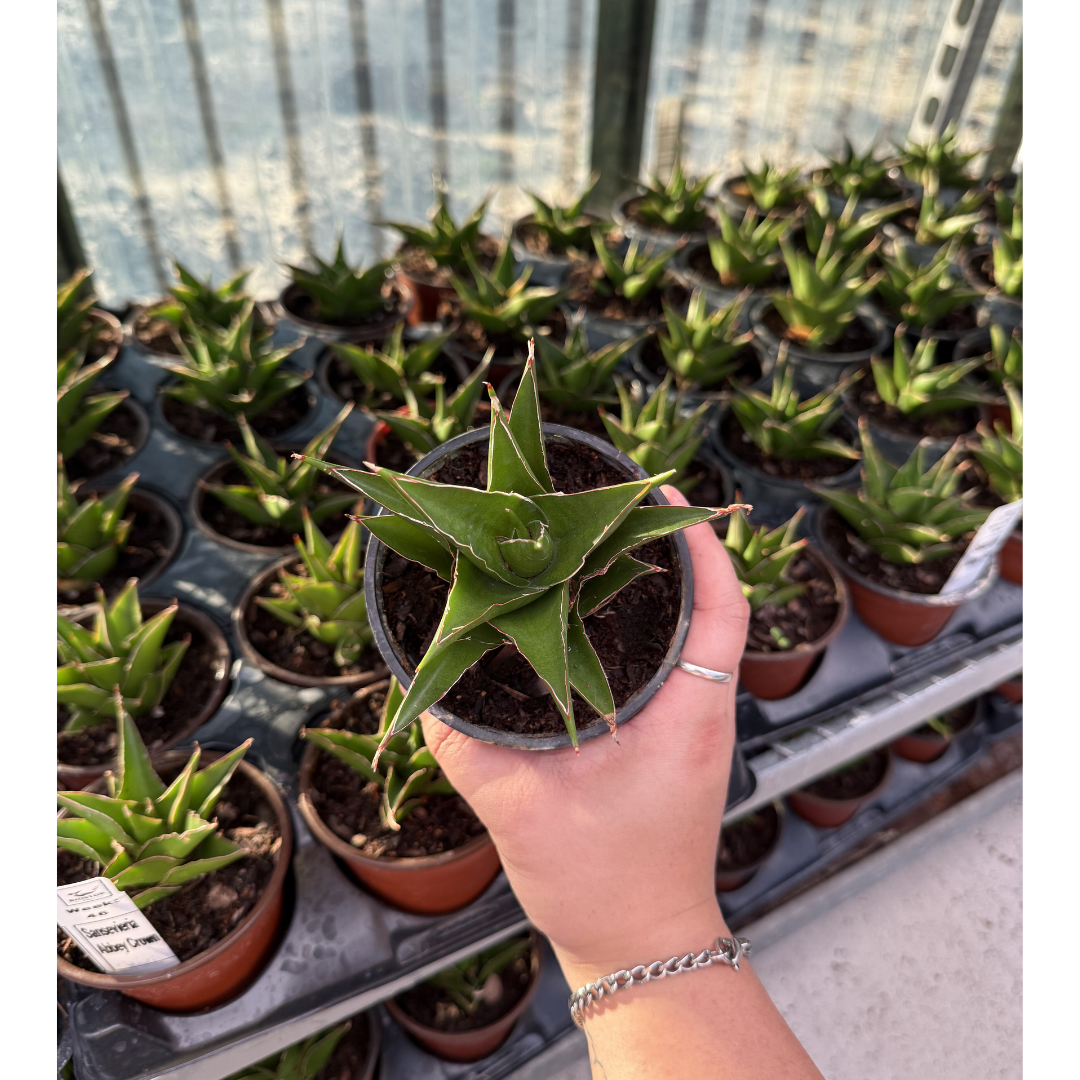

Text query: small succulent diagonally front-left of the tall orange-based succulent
(659, 288), (754, 389)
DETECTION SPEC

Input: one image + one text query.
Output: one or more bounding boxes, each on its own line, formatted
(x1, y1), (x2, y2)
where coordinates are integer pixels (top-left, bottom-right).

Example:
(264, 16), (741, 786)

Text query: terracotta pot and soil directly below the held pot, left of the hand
(298, 680), (500, 915)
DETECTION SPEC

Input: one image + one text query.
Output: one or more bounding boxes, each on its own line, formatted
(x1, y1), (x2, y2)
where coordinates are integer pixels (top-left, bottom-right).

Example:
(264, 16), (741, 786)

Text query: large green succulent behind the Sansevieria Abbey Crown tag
(56, 694), (252, 909)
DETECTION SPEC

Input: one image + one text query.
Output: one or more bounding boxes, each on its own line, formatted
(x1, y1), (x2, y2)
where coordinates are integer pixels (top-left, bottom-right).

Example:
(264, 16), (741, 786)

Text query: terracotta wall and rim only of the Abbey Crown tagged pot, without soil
(56, 754), (293, 1013)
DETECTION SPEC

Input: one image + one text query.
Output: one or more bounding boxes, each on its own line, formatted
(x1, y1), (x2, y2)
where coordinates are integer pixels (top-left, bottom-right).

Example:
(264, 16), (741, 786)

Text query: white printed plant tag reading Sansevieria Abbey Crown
(56, 878), (180, 975)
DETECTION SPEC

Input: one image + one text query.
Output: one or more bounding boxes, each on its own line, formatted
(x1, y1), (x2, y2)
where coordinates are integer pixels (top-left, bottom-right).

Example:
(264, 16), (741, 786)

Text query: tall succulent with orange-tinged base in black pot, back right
(772, 230), (882, 349)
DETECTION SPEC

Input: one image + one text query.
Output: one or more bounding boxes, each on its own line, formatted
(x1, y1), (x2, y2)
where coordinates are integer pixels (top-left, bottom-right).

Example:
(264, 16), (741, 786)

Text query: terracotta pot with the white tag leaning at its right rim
(813, 510), (998, 646)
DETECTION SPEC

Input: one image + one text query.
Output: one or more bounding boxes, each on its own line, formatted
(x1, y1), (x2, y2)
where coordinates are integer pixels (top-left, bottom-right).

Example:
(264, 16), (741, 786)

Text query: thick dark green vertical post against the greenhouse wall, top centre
(592, 0), (657, 208)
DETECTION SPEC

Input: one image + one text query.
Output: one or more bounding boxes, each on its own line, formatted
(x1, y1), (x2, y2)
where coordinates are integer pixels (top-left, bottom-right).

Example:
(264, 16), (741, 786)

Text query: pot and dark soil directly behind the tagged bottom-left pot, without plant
(56, 596), (232, 791)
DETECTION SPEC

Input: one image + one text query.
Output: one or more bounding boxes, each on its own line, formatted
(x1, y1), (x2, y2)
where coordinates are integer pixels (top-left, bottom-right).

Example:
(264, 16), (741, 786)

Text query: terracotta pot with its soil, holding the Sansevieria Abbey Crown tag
(56, 752), (293, 1013)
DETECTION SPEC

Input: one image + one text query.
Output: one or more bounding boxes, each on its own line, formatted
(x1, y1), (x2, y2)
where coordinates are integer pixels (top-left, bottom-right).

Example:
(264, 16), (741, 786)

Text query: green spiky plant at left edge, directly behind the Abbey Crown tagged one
(56, 578), (191, 731)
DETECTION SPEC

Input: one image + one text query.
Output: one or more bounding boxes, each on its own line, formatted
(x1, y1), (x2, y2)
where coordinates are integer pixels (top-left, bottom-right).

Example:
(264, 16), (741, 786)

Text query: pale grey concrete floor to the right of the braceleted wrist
(519, 773), (1024, 1080)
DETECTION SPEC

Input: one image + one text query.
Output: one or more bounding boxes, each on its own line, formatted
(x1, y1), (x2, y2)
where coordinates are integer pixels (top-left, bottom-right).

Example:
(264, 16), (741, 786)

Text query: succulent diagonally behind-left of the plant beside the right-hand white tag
(731, 342), (861, 461)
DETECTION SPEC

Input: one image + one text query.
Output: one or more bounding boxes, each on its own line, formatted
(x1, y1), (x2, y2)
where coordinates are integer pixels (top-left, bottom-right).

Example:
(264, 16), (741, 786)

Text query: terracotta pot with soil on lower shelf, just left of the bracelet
(386, 930), (543, 1062)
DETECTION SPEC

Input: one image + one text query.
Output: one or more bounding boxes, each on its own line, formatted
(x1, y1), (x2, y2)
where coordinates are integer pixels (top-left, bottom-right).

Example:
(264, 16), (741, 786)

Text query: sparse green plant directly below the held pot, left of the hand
(300, 678), (455, 832)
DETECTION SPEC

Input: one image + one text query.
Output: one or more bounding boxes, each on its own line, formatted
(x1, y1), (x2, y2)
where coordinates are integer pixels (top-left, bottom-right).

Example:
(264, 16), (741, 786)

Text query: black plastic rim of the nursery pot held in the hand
(364, 423), (695, 751)
